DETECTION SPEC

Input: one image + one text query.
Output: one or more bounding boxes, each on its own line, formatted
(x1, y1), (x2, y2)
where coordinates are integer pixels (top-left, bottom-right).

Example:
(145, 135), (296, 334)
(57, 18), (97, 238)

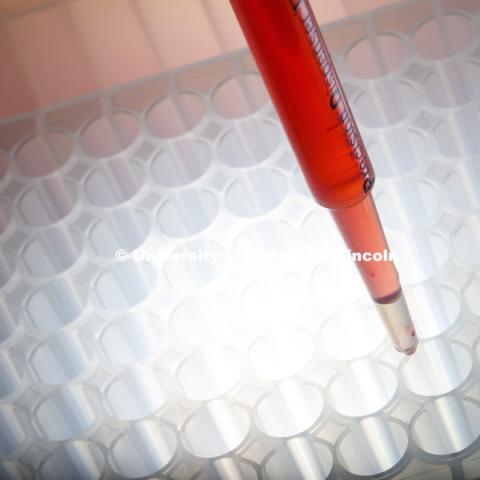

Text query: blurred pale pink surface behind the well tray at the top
(0, 0), (402, 117)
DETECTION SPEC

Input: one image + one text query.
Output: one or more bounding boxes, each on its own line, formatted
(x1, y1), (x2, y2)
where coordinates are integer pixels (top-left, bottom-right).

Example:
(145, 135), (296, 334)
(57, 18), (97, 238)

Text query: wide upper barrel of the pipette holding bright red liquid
(232, 0), (374, 208)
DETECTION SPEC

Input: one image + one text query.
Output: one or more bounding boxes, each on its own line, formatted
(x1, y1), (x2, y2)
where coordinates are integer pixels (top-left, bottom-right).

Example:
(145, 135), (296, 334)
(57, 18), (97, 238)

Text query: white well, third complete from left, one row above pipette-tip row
(175, 345), (242, 401)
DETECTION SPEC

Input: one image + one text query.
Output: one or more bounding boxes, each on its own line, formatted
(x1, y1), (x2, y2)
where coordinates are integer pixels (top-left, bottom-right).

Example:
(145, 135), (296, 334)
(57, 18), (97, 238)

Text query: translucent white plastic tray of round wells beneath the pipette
(0, 0), (480, 480)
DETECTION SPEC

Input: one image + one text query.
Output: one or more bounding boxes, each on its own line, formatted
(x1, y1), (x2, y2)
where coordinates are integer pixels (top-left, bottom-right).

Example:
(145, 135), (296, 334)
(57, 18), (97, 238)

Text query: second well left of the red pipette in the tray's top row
(146, 93), (205, 138)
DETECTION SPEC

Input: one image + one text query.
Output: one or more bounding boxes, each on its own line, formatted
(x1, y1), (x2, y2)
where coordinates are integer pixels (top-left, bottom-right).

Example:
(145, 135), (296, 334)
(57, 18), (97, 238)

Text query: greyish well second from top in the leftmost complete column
(18, 175), (77, 227)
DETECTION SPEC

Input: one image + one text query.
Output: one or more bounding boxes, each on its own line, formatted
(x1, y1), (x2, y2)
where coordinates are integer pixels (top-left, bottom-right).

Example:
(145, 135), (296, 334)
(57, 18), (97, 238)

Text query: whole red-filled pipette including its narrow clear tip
(230, 0), (417, 353)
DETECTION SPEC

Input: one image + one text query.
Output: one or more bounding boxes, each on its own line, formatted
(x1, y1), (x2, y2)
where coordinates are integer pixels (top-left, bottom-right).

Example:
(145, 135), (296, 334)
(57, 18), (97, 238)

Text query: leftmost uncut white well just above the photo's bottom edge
(109, 420), (177, 478)
